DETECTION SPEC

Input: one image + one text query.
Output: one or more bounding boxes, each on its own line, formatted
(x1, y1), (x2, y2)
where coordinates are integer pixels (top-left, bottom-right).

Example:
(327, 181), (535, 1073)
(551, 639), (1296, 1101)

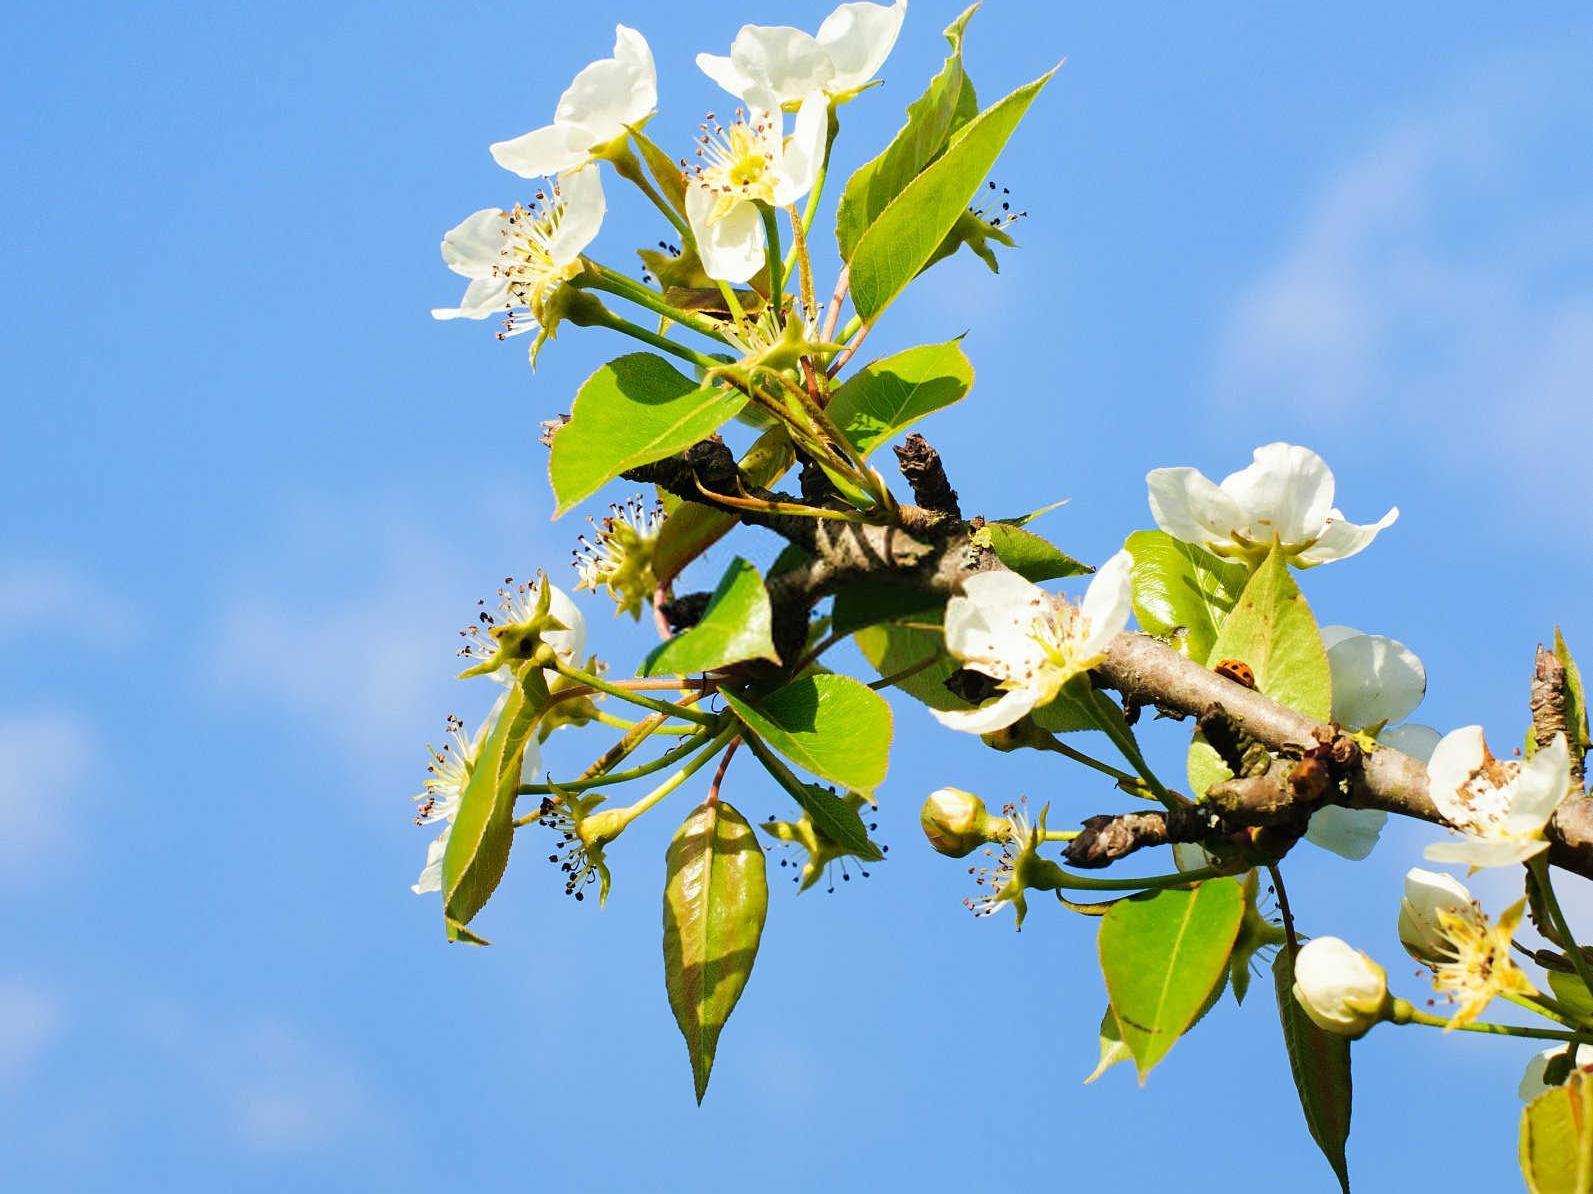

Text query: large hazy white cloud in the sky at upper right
(1215, 51), (1593, 506)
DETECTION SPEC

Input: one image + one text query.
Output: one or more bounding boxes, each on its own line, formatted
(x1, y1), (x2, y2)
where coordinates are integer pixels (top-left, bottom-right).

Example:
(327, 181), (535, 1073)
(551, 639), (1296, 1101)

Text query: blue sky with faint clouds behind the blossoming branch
(9, 0), (1593, 1191)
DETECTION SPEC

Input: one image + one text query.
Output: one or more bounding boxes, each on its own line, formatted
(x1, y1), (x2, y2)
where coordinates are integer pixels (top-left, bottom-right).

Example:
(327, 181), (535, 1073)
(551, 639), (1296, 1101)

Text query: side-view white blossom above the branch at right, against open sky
(1145, 444), (1399, 567)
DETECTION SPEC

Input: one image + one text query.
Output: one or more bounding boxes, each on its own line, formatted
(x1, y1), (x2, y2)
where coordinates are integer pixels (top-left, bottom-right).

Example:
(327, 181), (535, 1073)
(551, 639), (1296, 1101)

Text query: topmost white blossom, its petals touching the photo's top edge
(696, 0), (906, 108)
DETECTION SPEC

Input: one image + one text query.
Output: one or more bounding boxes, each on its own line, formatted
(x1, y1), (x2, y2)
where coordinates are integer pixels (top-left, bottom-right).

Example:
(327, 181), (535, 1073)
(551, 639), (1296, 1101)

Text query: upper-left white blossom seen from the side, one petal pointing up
(492, 25), (658, 178)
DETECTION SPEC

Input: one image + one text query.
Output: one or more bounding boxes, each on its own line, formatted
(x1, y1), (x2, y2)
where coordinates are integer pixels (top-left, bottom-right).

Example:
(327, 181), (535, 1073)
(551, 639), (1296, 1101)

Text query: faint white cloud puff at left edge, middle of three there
(0, 712), (94, 884)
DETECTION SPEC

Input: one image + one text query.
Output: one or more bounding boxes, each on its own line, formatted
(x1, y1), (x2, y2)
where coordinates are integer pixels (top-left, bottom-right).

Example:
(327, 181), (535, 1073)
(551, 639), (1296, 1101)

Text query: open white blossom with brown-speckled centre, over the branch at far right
(1424, 726), (1571, 869)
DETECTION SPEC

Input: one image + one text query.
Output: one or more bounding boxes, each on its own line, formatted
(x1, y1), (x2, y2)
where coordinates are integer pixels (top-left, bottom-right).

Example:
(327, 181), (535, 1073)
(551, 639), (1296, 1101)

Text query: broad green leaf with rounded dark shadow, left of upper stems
(548, 352), (747, 517)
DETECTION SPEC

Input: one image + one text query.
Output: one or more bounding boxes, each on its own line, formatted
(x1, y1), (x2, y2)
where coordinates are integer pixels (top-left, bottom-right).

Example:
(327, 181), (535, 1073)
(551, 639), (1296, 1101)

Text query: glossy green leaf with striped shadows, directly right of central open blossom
(1123, 530), (1249, 664)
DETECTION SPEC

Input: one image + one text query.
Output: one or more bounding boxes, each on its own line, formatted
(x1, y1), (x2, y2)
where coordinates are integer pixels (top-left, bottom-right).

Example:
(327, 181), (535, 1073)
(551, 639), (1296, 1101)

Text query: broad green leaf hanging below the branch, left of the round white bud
(1099, 879), (1244, 1083)
